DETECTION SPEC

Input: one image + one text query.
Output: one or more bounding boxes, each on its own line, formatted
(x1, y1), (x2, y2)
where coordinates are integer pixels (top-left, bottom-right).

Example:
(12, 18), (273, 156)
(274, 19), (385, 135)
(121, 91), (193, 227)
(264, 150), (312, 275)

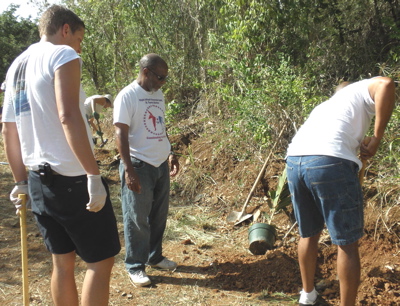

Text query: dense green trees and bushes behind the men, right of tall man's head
(65, 0), (400, 126)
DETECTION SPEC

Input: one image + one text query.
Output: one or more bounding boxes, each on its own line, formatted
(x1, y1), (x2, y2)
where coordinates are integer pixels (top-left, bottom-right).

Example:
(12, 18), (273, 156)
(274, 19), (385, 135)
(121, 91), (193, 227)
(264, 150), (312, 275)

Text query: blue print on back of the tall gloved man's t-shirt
(12, 59), (31, 116)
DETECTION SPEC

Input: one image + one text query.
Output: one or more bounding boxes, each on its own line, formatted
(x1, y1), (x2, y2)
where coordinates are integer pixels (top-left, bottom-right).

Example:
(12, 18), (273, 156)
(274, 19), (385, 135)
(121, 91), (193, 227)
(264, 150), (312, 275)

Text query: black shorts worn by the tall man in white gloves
(29, 171), (121, 263)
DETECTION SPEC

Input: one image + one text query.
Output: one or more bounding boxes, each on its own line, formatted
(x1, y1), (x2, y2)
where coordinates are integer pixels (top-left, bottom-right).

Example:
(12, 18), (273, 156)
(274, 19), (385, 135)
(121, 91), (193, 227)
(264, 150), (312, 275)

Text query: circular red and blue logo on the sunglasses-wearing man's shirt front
(143, 100), (166, 139)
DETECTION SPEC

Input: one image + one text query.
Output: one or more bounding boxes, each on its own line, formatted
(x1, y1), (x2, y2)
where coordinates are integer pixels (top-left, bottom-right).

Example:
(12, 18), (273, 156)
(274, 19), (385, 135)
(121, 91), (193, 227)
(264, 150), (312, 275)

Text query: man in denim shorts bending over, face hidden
(286, 77), (395, 305)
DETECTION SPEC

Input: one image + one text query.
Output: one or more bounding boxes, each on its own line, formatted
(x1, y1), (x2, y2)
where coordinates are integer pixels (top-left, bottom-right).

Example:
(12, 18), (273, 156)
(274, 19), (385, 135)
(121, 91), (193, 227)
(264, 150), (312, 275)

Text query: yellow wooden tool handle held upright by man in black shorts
(18, 194), (29, 306)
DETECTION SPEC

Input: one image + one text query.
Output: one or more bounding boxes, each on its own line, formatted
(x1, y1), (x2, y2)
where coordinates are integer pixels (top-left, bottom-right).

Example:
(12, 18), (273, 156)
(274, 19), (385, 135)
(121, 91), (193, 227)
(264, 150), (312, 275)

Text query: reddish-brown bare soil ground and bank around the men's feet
(0, 118), (400, 305)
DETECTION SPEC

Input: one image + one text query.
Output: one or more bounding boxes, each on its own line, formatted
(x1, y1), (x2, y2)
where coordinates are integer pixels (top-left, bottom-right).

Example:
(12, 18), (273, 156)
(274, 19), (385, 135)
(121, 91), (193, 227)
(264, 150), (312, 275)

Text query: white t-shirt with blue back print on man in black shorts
(3, 42), (93, 176)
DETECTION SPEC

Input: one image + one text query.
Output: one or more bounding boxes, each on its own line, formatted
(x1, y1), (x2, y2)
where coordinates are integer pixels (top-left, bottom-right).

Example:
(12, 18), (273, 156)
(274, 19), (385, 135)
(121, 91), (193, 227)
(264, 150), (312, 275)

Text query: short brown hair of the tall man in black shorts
(39, 5), (85, 36)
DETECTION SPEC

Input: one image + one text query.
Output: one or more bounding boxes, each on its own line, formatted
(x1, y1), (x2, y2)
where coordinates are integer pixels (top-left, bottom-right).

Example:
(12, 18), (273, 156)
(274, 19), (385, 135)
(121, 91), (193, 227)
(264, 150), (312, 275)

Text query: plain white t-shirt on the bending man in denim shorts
(287, 79), (375, 168)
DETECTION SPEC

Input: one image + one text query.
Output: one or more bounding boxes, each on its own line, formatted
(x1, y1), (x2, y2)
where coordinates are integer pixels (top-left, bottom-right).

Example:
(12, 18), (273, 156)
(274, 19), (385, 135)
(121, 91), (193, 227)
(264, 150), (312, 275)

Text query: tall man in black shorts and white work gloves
(3, 5), (120, 306)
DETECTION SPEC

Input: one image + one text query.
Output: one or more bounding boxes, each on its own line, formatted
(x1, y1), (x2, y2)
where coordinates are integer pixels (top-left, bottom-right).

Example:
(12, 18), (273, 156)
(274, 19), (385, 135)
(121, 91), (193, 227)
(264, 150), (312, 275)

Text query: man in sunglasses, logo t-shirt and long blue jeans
(114, 53), (179, 286)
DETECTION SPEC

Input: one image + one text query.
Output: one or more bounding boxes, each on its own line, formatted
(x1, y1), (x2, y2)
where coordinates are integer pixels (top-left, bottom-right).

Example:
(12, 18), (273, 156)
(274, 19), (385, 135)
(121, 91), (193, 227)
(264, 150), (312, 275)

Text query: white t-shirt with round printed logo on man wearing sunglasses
(113, 81), (171, 167)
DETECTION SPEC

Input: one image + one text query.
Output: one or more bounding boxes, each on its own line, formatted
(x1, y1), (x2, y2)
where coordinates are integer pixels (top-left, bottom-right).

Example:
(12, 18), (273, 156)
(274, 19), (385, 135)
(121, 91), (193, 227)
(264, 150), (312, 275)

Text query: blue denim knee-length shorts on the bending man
(286, 155), (364, 245)
